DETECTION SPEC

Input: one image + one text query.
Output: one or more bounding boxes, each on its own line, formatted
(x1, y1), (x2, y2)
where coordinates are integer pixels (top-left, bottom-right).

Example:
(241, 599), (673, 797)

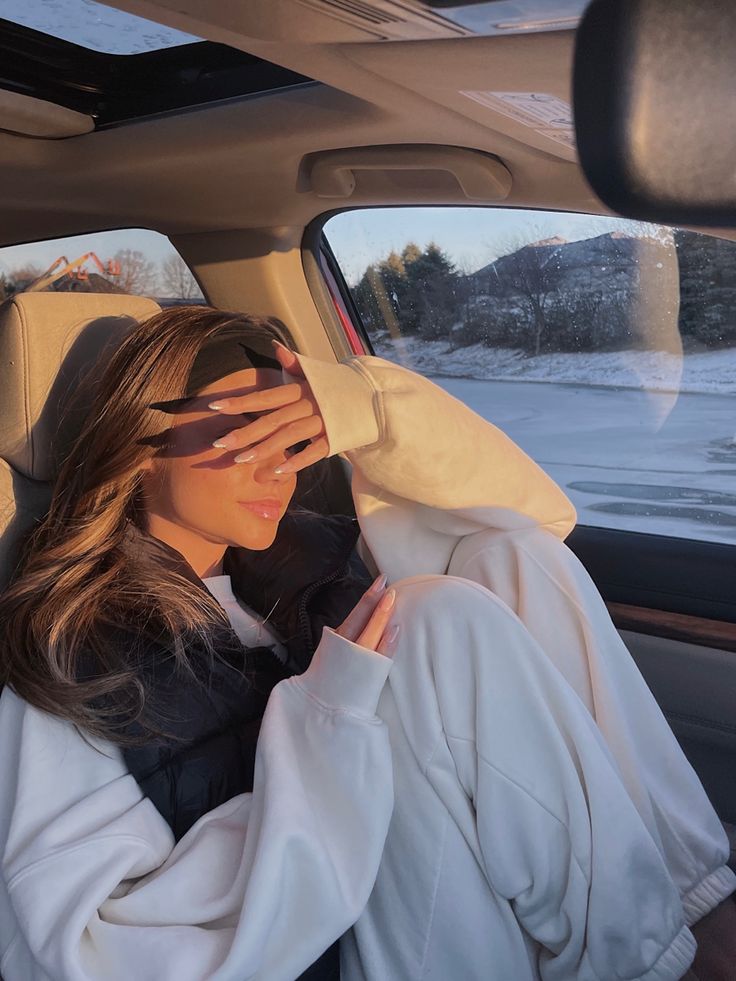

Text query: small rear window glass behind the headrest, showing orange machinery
(0, 228), (204, 306)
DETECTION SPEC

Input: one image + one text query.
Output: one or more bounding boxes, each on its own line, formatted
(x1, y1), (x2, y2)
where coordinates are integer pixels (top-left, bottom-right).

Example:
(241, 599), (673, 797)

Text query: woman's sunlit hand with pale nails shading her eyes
(209, 341), (330, 473)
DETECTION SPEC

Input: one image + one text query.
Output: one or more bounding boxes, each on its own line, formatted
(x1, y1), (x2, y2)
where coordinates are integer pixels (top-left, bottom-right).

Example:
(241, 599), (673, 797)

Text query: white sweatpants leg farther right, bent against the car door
(449, 529), (736, 925)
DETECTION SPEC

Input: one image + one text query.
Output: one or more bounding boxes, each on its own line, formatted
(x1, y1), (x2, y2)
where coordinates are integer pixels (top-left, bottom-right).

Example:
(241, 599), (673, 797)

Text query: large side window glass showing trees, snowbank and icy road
(325, 208), (736, 542)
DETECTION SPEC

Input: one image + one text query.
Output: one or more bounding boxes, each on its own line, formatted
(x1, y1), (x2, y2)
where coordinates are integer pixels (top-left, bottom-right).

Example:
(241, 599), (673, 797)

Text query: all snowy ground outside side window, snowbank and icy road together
(376, 341), (736, 543)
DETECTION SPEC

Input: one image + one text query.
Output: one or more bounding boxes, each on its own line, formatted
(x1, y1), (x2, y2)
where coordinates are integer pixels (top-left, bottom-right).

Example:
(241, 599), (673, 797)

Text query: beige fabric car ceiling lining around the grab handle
(0, 0), (727, 253)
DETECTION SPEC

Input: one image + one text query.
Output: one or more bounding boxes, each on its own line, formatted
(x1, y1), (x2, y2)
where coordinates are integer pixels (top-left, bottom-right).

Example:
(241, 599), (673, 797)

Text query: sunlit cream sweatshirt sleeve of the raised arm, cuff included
(284, 355), (576, 582)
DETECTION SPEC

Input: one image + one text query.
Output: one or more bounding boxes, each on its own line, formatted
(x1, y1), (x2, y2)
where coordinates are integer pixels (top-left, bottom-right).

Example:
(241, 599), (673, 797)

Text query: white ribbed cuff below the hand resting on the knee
(292, 627), (393, 718)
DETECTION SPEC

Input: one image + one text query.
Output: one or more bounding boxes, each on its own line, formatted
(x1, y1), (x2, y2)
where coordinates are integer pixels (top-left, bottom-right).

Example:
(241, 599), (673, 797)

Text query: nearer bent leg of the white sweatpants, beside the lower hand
(342, 548), (730, 981)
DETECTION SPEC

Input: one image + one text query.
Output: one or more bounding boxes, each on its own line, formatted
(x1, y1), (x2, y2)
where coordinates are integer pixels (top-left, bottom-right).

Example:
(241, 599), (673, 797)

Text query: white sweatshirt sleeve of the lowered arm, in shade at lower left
(0, 628), (393, 981)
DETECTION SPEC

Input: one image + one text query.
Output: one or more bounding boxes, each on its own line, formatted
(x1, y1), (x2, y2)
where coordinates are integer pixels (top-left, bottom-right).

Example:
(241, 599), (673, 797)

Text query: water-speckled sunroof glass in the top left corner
(2, 0), (202, 54)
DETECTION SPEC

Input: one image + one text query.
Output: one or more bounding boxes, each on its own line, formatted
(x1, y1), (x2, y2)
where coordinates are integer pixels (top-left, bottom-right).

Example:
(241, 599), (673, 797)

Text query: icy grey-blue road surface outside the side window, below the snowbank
(432, 375), (736, 543)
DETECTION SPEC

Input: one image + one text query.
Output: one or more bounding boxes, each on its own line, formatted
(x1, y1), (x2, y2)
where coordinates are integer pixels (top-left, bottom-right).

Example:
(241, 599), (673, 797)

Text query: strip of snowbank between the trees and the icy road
(372, 332), (736, 395)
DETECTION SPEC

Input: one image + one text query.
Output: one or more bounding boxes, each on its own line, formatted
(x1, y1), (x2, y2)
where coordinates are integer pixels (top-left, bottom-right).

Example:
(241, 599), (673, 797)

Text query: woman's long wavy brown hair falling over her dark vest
(0, 306), (296, 746)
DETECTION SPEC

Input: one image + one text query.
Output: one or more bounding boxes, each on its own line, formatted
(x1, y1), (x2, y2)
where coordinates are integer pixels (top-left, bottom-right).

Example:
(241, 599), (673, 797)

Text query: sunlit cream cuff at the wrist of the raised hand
(282, 352), (381, 456)
